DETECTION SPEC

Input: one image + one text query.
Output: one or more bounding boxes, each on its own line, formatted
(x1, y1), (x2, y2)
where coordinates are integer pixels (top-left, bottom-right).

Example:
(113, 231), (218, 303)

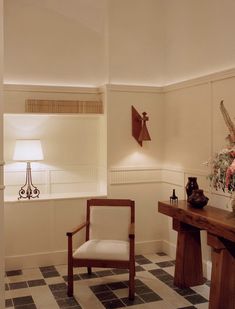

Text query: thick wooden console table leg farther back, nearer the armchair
(173, 219), (204, 288)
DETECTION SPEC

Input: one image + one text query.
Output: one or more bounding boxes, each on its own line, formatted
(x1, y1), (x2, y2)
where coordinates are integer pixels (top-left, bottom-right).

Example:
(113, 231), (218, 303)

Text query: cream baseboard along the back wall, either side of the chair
(5, 240), (162, 270)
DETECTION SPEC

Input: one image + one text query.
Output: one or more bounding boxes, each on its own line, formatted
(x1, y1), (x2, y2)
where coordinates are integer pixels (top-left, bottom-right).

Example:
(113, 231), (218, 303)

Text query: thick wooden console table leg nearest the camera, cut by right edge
(207, 233), (235, 309)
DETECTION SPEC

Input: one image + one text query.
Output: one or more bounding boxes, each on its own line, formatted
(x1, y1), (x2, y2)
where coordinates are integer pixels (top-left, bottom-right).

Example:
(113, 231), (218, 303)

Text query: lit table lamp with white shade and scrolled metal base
(13, 139), (43, 200)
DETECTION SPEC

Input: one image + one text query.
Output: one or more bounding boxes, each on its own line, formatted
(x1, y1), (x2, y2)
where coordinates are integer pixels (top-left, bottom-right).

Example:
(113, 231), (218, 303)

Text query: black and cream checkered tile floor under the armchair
(5, 252), (210, 309)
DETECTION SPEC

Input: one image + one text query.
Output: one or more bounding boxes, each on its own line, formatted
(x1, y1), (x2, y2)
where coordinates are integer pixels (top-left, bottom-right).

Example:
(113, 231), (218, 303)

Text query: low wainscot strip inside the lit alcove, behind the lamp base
(4, 165), (104, 200)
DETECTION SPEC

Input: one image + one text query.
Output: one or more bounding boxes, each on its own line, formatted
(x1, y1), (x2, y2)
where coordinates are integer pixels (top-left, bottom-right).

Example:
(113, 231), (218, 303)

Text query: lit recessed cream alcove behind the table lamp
(4, 114), (107, 201)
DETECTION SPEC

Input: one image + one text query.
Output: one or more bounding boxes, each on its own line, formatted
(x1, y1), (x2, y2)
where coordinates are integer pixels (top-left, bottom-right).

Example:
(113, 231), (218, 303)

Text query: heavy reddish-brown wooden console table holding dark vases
(158, 201), (235, 309)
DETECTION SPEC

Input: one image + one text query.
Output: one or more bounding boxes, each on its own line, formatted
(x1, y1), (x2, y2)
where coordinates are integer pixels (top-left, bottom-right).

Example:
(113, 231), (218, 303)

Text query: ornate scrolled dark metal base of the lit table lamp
(18, 162), (40, 200)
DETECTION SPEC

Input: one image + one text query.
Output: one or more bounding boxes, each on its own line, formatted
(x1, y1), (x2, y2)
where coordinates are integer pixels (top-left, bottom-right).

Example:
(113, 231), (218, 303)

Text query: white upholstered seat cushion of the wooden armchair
(73, 239), (130, 261)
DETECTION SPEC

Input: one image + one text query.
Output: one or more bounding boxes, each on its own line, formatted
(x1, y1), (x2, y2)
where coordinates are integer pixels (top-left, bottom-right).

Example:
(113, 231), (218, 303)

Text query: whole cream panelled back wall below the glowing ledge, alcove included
(4, 85), (166, 269)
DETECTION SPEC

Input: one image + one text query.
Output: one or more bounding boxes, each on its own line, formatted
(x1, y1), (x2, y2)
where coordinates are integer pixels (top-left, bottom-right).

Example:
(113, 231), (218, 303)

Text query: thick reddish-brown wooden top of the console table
(158, 200), (235, 242)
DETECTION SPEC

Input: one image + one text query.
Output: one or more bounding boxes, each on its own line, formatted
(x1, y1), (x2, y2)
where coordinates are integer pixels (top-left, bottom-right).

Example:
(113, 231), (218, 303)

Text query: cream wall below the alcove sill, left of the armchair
(5, 198), (86, 269)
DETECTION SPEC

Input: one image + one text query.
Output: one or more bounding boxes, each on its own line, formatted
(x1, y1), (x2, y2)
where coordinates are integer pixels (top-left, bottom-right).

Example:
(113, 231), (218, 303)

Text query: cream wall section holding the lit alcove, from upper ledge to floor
(4, 85), (107, 269)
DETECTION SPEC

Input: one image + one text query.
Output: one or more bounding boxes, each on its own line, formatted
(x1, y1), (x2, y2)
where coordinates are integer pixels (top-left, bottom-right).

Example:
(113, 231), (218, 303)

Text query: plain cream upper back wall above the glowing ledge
(4, 0), (164, 86)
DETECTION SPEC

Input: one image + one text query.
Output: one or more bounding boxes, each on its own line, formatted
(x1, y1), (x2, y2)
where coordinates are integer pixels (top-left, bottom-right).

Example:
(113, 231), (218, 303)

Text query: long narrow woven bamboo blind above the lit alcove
(25, 99), (103, 114)
